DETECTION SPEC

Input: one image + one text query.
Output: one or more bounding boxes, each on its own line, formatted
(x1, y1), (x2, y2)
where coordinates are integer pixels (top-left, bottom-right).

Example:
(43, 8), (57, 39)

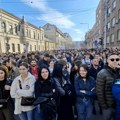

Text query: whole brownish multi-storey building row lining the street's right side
(86, 0), (120, 48)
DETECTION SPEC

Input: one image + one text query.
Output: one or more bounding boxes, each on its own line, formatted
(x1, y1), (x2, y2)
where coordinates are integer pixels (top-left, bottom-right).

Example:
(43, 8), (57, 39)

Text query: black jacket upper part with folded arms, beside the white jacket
(35, 78), (65, 104)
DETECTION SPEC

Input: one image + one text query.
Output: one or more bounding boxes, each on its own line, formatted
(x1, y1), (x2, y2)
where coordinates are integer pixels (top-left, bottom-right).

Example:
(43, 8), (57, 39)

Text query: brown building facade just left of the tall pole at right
(85, 0), (105, 48)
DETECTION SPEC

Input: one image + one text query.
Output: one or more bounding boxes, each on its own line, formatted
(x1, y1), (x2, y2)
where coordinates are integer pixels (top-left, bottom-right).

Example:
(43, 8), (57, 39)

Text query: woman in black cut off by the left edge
(0, 67), (14, 120)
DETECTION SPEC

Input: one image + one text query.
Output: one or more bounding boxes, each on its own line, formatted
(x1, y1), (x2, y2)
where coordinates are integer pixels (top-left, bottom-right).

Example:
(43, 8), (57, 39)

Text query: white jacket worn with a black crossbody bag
(10, 73), (36, 114)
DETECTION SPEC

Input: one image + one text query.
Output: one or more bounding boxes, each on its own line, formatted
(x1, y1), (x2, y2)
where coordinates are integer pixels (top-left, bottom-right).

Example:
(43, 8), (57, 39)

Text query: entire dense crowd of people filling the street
(0, 48), (120, 120)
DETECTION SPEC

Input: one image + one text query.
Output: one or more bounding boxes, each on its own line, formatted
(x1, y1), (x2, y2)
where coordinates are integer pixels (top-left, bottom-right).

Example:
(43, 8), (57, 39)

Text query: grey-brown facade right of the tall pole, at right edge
(106, 0), (120, 48)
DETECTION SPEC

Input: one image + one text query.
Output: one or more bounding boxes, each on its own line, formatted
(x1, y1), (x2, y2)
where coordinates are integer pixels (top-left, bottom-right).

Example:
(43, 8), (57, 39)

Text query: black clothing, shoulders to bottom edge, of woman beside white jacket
(35, 79), (65, 120)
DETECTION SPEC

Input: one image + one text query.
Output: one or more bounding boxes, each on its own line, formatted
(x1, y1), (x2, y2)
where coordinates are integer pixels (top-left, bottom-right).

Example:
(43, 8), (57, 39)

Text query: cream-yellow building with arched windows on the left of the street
(0, 9), (45, 53)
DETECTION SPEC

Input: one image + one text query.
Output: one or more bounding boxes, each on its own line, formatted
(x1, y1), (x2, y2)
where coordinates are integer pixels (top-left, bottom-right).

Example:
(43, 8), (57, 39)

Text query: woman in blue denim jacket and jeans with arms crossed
(74, 64), (95, 120)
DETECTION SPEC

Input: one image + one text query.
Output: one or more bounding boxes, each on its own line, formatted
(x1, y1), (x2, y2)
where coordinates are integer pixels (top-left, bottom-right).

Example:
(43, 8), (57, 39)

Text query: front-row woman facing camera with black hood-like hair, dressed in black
(35, 66), (65, 120)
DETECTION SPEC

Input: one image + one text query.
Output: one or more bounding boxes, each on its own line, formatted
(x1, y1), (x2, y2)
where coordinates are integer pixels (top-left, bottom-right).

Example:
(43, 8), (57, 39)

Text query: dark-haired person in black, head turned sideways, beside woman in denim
(52, 63), (74, 120)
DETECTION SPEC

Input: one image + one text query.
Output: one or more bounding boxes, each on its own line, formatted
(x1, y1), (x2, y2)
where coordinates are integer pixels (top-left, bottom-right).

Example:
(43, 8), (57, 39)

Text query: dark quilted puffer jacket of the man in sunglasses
(96, 66), (117, 109)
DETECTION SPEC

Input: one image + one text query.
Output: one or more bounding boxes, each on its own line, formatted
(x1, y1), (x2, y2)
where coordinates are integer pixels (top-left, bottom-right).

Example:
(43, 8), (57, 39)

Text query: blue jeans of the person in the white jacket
(19, 110), (34, 120)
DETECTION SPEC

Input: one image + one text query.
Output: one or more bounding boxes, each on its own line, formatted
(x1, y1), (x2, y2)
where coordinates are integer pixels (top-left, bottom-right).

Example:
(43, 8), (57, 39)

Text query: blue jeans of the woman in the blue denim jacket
(76, 101), (93, 120)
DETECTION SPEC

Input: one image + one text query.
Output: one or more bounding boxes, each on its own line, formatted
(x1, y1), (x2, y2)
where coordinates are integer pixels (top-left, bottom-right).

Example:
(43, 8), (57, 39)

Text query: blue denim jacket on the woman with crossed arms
(74, 76), (96, 102)
